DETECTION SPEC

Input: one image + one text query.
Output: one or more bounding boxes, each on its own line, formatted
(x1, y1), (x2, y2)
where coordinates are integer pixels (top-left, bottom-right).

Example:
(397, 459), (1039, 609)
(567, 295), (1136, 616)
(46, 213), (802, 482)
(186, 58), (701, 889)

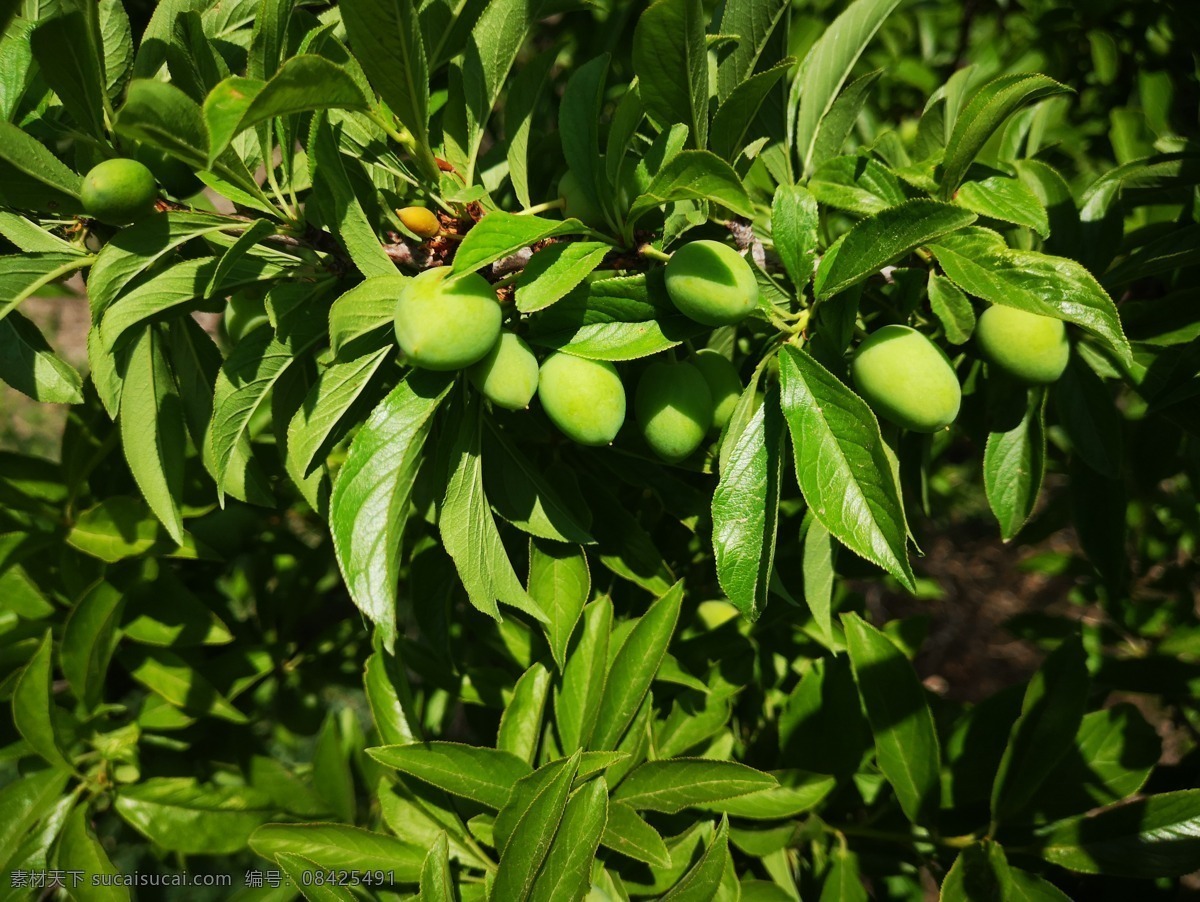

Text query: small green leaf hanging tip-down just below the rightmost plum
(983, 390), (1046, 542)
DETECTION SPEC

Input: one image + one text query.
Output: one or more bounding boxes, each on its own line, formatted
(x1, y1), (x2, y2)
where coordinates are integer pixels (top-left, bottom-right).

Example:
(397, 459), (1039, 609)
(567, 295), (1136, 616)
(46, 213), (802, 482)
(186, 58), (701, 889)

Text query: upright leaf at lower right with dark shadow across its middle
(841, 614), (941, 824)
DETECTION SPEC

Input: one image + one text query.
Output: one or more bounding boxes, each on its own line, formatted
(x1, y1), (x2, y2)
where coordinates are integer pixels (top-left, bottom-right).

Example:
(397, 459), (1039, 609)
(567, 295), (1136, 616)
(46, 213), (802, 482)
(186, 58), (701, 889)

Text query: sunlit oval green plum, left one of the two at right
(850, 325), (962, 432)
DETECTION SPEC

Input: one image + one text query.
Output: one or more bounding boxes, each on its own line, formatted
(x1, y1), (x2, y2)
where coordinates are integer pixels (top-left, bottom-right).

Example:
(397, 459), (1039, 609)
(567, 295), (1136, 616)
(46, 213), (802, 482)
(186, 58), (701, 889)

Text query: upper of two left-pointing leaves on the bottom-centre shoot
(367, 742), (533, 810)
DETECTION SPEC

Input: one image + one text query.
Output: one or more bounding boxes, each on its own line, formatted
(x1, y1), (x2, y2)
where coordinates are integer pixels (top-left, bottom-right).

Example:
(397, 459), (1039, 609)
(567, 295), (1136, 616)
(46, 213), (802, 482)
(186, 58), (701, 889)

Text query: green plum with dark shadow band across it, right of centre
(666, 240), (758, 326)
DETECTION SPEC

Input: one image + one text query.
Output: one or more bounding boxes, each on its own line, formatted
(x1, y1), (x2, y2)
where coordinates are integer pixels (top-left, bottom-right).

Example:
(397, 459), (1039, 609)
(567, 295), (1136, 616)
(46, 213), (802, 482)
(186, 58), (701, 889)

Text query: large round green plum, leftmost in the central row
(395, 266), (502, 371)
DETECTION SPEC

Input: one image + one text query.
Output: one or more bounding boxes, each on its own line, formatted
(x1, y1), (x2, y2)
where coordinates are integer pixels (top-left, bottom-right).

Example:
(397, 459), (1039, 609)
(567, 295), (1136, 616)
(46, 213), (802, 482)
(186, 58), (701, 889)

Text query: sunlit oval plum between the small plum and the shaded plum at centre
(538, 351), (625, 445)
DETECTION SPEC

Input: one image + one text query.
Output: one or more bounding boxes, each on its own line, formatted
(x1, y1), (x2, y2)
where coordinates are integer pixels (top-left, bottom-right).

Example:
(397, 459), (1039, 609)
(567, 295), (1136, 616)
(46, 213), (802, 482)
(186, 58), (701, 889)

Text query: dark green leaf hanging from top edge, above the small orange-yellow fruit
(340, 0), (437, 175)
